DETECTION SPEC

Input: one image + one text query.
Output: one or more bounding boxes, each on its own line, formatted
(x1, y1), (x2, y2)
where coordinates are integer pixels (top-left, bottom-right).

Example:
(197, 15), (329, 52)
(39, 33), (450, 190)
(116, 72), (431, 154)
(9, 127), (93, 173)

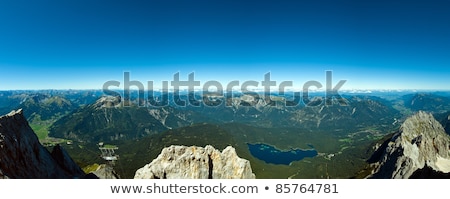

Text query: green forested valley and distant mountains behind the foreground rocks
(0, 90), (450, 178)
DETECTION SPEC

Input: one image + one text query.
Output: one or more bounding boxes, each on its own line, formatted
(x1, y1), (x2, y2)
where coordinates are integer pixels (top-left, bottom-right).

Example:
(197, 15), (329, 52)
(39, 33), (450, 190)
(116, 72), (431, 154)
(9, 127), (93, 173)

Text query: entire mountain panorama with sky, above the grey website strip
(0, 0), (450, 182)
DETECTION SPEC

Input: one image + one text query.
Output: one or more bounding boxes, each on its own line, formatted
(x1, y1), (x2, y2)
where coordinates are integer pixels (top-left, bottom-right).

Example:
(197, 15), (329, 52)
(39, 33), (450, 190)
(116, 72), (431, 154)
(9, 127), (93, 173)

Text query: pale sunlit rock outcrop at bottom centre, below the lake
(134, 145), (255, 179)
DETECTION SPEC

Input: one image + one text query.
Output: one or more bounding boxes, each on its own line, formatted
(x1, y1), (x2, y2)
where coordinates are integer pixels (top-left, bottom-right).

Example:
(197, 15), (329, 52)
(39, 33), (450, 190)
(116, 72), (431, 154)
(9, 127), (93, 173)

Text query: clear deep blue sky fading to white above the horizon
(0, 0), (450, 90)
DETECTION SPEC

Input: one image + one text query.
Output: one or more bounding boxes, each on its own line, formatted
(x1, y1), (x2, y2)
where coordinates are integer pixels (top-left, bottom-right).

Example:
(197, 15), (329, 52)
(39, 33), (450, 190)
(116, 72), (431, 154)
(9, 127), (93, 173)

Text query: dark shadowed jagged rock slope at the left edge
(0, 109), (84, 179)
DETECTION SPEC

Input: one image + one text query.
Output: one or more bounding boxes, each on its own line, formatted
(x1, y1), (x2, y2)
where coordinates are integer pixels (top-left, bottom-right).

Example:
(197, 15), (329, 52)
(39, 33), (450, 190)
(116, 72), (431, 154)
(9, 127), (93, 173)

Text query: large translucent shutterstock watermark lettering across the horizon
(103, 71), (348, 107)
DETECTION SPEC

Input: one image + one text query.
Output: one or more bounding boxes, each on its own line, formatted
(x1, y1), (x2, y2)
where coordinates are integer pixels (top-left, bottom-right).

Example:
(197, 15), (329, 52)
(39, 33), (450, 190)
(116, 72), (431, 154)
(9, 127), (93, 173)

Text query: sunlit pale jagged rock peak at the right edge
(369, 111), (450, 178)
